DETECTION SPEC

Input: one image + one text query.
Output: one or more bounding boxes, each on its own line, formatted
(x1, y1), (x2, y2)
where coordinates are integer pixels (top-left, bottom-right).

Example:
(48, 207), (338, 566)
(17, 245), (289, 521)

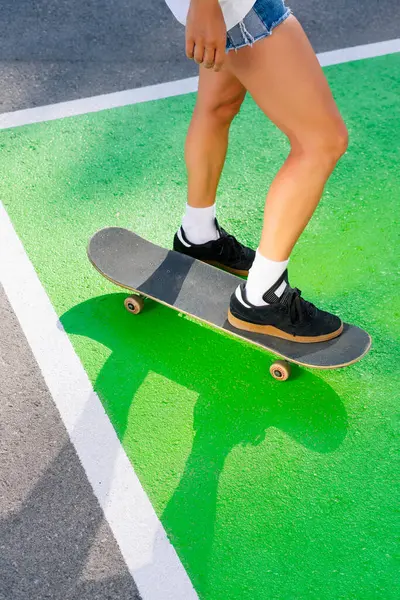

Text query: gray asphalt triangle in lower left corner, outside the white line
(0, 286), (140, 600)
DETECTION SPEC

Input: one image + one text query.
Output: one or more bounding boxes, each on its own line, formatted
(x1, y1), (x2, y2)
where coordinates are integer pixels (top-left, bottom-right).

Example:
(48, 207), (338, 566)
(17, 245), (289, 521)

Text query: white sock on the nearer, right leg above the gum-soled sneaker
(246, 250), (289, 306)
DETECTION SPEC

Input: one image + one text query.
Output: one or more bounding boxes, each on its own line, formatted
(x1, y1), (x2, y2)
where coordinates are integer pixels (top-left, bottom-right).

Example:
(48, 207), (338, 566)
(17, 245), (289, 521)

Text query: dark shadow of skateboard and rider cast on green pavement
(60, 293), (347, 595)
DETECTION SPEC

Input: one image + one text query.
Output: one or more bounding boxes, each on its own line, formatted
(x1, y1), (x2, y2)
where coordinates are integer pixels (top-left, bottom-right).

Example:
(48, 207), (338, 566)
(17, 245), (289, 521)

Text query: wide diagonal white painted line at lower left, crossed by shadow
(0, 202), (198, 600)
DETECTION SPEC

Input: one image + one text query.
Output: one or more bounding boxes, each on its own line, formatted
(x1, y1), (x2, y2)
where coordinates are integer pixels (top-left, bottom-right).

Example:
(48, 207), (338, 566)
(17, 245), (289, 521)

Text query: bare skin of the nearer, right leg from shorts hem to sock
(227, 16), (347, 261)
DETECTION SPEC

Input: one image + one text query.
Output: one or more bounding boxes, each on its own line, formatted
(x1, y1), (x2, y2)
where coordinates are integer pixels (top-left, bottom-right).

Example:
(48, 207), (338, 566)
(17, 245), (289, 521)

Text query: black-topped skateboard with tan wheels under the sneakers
(87, 227), (371, 381)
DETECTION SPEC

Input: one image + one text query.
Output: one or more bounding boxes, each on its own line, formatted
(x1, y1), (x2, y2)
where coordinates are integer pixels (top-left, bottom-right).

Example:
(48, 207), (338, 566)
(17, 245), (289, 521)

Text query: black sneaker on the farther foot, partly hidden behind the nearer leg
(174, 220), (256, 276)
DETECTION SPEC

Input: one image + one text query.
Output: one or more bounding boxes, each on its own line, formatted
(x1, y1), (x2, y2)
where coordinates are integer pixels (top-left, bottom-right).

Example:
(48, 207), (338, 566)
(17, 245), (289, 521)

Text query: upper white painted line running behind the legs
(0, 39), (400, 129)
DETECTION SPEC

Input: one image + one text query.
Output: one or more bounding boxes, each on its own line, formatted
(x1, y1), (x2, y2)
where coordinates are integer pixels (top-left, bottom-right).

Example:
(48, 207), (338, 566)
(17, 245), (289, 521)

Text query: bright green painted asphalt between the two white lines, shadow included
(0, 55), (400, 600)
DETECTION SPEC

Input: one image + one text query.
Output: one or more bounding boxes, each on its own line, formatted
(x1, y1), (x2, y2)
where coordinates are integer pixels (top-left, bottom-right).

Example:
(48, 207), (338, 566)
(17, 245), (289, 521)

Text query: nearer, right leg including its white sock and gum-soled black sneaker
(227, 16), (347, 342)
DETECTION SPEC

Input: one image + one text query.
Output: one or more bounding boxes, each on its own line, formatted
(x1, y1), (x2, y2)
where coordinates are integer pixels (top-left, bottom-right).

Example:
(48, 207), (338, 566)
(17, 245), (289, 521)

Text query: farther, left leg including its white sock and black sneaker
(174, 68), (255, 275)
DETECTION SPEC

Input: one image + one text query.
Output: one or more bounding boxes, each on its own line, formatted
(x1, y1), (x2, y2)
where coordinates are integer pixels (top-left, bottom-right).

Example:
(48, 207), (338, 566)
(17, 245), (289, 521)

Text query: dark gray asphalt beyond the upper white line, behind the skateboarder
(0, 0), (400, 112)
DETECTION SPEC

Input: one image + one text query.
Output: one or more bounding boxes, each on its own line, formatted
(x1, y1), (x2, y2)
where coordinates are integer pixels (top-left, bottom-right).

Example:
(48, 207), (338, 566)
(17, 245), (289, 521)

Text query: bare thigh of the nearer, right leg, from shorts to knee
(226, 16), (345, 141)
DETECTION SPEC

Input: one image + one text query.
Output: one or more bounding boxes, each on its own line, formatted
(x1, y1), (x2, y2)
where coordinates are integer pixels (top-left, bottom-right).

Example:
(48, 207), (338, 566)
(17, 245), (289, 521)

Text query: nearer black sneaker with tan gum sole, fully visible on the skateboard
(228, 271), (343, 343)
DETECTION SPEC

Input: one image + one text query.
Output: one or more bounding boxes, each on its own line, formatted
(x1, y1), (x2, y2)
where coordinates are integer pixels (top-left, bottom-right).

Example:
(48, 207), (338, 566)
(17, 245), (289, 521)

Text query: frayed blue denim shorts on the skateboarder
(226, 0), (291, 52)
